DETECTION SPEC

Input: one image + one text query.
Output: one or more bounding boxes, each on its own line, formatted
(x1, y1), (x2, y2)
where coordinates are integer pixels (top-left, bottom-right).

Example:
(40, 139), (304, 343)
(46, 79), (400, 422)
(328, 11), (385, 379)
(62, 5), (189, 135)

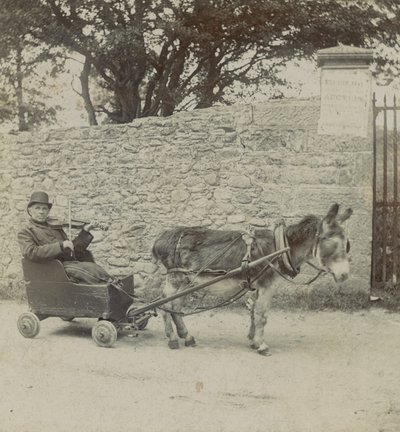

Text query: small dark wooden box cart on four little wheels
(17, 259), (154, 347)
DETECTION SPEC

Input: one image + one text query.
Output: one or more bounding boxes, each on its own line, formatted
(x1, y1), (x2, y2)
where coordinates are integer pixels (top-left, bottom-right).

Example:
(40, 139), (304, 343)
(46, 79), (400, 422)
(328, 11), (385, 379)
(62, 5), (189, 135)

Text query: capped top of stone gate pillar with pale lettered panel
(317, 45), (373, 137)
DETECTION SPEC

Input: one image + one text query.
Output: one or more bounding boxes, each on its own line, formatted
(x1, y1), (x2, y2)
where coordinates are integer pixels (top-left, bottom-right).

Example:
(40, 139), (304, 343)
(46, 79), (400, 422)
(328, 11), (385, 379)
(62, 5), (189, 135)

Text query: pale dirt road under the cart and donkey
(0, 302), (400, 432)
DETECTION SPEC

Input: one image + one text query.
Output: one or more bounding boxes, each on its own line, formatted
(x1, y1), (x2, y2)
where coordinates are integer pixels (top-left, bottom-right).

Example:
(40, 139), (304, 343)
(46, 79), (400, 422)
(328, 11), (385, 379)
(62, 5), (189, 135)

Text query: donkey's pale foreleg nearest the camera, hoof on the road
(251, 287), (273, 355)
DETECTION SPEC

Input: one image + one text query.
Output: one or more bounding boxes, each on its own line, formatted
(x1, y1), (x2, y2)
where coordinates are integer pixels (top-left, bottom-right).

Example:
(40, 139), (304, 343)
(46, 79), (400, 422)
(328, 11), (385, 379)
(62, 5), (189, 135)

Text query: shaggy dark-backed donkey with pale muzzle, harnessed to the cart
(153, 204), (352, 355)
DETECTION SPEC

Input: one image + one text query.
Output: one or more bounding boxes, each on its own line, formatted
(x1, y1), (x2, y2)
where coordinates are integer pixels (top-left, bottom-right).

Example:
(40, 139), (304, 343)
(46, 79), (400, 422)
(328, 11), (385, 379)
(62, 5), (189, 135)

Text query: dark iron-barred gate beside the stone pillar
(371, 94), (400, 289)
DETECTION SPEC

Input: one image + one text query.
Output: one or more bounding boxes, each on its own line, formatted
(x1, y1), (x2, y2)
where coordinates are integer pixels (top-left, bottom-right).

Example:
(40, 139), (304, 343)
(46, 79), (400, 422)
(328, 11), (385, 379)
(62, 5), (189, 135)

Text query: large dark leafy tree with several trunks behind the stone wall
(0, 0), (390, 123)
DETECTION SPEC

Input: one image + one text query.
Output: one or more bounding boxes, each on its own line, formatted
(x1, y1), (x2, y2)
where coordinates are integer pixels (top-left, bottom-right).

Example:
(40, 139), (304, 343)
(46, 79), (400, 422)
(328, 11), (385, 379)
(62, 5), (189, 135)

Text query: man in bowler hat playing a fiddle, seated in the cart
(18, 192), (112, 284)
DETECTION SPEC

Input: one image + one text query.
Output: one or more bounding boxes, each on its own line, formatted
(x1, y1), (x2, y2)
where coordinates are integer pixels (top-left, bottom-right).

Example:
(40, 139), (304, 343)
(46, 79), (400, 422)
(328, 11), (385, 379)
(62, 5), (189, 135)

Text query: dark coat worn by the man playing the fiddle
(18, 220), (93, 261)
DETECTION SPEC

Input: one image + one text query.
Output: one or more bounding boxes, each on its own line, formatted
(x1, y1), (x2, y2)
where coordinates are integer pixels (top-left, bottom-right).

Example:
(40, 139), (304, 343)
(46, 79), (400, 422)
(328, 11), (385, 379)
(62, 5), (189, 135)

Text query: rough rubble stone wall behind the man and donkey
(0, 100), (373, 296)
